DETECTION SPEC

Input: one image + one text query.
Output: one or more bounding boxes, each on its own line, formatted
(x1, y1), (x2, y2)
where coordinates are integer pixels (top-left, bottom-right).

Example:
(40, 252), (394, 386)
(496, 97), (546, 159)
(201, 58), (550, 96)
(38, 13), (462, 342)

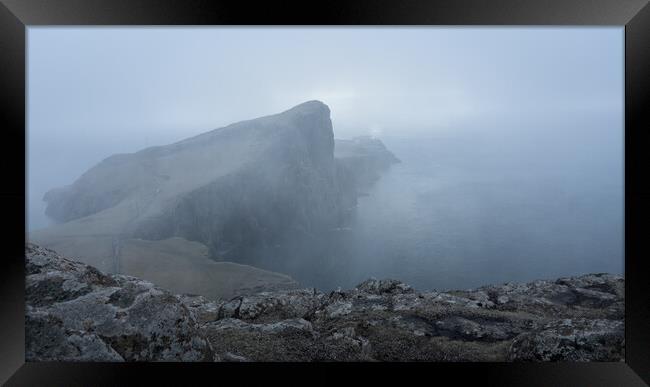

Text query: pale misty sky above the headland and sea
(27, 27), (624, 233)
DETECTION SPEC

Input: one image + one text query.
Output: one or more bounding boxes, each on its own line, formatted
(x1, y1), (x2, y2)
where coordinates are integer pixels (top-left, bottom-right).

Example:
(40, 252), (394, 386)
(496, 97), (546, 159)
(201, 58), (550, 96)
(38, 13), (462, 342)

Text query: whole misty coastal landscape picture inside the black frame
(21, 25), (626, 362)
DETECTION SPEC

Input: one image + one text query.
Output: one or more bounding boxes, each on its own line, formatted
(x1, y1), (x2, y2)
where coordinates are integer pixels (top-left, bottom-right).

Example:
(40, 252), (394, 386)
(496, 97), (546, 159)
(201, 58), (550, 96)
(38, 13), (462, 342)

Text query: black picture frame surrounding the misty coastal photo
(0, 0), (650, 386)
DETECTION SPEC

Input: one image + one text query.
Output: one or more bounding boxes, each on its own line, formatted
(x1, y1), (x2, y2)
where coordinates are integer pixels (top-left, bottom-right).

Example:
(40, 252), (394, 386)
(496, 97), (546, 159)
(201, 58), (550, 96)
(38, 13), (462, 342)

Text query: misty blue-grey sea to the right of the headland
(275, 116), (624, 290)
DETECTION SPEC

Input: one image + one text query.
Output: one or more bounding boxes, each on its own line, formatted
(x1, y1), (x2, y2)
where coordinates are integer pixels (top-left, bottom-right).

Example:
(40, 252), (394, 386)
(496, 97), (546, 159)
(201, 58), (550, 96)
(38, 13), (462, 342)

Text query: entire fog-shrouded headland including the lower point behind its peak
(30, 101), (394, 285)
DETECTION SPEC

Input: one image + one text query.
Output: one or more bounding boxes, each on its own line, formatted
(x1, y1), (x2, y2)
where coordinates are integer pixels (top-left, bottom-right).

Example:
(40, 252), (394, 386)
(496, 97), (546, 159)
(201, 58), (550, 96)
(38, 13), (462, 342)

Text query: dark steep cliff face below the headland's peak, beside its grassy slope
(123, 102), (343, 261)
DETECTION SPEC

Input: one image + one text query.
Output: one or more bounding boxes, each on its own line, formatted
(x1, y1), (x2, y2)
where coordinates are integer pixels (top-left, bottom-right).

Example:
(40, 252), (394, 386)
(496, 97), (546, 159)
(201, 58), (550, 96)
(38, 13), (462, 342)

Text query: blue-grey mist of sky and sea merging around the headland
(26, 27), (624, 290)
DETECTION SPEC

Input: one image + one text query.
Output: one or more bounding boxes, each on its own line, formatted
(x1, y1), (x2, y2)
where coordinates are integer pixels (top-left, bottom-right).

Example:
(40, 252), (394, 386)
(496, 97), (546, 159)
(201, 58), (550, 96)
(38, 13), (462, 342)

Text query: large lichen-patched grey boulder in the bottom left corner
(25, 244), (214, 361)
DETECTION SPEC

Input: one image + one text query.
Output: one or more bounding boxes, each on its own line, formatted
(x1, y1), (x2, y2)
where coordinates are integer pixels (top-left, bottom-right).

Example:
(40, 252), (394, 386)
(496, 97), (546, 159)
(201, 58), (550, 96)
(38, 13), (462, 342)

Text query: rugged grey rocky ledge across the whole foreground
(25, 244), (625, 361)
